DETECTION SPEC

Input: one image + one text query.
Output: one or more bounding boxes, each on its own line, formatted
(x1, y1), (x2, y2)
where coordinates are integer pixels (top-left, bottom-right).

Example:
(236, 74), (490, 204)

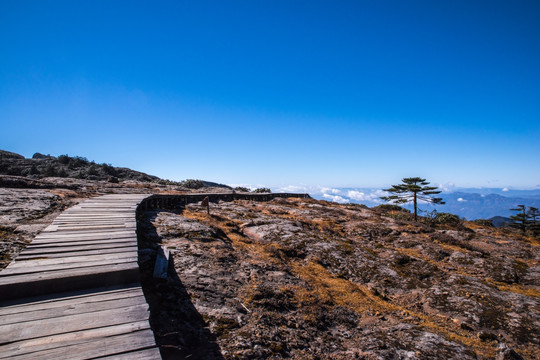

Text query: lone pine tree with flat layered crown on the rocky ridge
(381, 177), (444, 221)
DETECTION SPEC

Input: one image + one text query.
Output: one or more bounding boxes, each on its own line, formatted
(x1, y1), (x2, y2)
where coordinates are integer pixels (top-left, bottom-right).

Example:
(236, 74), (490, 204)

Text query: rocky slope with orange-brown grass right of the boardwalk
(139, 199), (540, 359)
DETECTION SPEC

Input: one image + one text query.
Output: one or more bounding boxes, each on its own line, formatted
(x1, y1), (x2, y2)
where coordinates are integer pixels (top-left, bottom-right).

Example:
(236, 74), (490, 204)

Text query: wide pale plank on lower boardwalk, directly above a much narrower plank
(0, 303), (148, 344)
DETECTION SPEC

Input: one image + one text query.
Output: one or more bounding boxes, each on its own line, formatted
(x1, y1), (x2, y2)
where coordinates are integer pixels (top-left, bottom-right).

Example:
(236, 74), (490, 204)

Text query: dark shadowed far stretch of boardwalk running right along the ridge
(138, 193), (311, 211)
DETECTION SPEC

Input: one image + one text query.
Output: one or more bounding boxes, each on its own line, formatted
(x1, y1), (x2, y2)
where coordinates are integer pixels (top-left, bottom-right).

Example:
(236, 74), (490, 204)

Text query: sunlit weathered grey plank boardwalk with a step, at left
(0, 195), (161, 360)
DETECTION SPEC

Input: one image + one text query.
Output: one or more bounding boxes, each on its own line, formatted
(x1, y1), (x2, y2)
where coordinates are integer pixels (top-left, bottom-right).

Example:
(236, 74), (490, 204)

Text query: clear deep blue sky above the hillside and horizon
(0, 0), (540, 187)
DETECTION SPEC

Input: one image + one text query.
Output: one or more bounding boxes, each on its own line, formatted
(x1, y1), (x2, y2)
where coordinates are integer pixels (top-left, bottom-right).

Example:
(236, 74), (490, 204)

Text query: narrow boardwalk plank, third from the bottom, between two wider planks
(0, 320), (151, 359)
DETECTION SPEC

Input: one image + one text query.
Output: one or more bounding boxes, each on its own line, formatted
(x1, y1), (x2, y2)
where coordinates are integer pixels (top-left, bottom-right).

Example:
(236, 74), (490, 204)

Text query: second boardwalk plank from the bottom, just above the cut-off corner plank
(4, 329), (155, 360)
